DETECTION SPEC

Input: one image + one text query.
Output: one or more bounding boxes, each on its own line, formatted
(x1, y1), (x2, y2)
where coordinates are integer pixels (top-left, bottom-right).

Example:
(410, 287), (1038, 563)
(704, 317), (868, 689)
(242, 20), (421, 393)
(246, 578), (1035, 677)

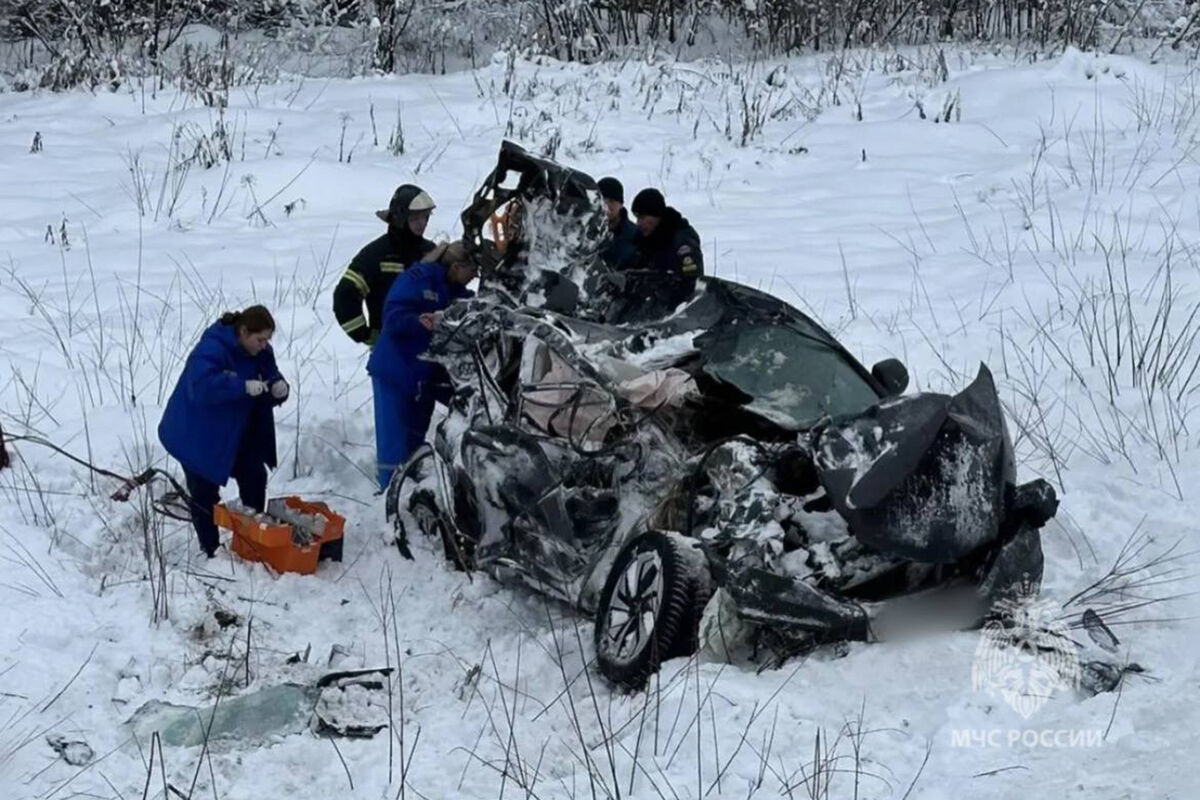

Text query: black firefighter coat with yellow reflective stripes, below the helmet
(334, 227), (433, 342)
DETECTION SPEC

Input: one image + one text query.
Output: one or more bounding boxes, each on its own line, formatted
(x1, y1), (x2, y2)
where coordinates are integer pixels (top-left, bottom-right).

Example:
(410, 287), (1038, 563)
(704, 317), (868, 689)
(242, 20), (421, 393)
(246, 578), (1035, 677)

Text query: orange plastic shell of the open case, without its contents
(212, 497), (346, 575)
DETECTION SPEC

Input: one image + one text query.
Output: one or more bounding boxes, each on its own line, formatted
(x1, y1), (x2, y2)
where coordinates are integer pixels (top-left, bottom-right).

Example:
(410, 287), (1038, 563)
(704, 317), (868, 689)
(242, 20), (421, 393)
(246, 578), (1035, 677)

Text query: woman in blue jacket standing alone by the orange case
(158, 306), (289, 558)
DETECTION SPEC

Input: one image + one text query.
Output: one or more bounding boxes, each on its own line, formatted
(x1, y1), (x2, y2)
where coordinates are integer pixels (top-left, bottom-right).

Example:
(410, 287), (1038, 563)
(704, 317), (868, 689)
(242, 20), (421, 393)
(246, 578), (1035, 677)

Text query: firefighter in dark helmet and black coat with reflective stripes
(334, 184), (437, 347)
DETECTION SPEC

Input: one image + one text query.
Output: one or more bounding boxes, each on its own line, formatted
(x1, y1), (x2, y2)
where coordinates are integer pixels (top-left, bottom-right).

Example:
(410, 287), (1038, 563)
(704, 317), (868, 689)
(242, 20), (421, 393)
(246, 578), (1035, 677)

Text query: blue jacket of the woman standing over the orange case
(158, 323), (283, 486)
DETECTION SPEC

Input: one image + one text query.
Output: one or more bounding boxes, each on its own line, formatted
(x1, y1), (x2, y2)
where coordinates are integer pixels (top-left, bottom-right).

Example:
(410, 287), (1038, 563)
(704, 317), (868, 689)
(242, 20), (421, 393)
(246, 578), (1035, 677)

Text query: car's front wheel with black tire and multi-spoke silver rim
(593, 530), (696, 691)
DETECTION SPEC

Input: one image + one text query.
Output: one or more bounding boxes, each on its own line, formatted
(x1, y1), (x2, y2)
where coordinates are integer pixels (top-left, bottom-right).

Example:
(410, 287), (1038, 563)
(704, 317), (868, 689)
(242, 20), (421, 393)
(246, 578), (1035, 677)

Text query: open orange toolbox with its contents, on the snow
(212, 497), (346, 575)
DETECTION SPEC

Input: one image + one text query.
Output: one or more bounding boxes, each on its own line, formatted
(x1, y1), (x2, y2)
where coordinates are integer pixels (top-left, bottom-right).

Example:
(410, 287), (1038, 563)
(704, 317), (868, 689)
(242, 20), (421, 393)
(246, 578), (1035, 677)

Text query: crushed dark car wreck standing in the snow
(386, 143), (1056, 688)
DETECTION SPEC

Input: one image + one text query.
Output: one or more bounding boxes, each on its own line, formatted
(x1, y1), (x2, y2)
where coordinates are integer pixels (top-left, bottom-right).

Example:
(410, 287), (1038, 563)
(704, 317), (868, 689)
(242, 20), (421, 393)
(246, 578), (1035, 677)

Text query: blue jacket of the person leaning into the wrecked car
(367, 263), (474, 396)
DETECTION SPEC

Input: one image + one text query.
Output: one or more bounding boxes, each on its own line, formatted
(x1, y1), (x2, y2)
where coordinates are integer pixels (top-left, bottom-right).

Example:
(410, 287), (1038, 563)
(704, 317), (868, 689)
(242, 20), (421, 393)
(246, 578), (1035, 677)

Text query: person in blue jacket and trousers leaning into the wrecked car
(367, 242), (479, 491)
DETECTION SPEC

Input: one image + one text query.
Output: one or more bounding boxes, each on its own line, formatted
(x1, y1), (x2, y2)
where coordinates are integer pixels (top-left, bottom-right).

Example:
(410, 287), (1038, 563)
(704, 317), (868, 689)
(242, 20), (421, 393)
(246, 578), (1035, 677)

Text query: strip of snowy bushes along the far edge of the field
(0, 0), (1200, 90)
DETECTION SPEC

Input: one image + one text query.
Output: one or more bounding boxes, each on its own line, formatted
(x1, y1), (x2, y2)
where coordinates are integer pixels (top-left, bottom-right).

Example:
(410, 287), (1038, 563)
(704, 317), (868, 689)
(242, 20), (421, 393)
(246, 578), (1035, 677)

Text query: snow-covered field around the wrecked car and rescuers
(0, 45), (1200, 800)
